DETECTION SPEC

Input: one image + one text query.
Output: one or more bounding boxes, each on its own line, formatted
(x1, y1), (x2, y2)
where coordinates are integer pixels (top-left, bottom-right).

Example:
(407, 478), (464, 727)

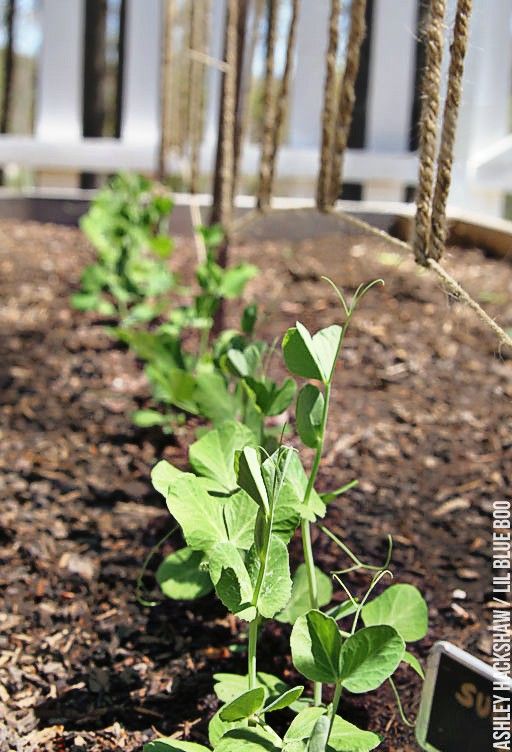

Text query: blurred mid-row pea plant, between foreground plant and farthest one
(116, 226), (296, 440)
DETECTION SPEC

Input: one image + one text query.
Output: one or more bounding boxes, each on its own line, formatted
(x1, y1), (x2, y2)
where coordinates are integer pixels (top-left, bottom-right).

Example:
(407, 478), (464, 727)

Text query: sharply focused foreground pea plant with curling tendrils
(144, 282), (428, 752)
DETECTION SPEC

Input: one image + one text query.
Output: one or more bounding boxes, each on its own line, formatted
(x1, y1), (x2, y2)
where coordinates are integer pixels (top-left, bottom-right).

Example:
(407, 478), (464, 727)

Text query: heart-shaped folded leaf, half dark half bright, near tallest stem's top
(283, 321), (343, 384)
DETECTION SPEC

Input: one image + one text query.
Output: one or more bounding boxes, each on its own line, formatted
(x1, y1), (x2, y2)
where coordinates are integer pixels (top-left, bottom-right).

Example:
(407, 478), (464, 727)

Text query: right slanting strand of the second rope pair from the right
(328, 0), (366, 206)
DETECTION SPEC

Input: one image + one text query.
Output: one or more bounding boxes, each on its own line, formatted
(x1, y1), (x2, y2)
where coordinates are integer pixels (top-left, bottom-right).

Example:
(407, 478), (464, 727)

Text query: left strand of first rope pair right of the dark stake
(257, 0), (279, 209)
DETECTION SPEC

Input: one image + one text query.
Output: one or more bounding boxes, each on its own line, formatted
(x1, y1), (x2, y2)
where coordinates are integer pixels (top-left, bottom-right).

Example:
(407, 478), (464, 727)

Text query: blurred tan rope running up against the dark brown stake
(219, 0), (238, 234)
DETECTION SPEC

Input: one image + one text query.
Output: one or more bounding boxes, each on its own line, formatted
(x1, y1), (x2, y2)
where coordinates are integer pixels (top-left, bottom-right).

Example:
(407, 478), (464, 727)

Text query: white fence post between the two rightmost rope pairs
(364, 0), (417, 201)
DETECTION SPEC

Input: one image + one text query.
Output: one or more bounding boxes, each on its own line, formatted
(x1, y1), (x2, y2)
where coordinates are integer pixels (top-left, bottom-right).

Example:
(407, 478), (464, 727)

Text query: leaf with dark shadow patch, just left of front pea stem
(208, 543), (255, 620)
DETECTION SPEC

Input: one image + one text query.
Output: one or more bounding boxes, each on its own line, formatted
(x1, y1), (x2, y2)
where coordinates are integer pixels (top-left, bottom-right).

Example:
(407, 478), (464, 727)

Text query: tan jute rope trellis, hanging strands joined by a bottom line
(179, 0), (512, 348)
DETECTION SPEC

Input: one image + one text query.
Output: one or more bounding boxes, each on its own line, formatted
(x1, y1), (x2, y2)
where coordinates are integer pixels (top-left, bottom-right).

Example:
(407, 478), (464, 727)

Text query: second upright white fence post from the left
(121, 0), (162, 154)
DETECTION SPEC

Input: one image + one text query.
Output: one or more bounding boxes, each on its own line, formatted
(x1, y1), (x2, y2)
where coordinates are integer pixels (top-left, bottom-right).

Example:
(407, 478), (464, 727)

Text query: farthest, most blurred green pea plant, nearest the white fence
(71, 174), (175, 325)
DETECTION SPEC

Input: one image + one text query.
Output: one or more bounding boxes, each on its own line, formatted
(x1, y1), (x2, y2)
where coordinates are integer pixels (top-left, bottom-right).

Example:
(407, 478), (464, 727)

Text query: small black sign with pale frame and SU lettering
(416, 641), (512, 752)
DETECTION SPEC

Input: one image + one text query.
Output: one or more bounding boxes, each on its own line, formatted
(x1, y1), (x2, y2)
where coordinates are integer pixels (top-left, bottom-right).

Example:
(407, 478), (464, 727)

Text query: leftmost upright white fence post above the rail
(35, 0), (84, 143)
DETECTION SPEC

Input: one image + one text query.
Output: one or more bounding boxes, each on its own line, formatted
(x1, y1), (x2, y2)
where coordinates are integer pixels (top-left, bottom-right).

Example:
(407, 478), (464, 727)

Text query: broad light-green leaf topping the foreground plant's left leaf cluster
(188, 420), (255, 491)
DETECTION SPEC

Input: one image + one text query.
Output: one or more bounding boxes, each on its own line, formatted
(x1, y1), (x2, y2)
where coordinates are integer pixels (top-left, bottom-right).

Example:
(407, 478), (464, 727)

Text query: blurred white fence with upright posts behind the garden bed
(0, 0), (512, 215)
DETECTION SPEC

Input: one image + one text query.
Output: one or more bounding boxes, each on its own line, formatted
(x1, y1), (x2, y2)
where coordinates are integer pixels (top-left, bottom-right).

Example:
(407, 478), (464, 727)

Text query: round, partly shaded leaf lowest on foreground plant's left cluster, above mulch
(156, 548), (212, 600)
